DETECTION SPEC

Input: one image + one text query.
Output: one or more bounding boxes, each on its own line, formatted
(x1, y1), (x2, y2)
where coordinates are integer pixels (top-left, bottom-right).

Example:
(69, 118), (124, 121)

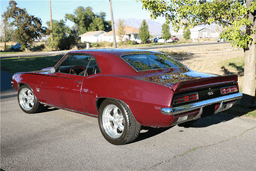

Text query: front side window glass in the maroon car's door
(57, 54), (91, 76)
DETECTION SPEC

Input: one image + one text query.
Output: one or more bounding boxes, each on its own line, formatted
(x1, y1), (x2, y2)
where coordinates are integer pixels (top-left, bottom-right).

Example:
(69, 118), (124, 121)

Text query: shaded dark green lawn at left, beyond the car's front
(1, 55), (63, 73)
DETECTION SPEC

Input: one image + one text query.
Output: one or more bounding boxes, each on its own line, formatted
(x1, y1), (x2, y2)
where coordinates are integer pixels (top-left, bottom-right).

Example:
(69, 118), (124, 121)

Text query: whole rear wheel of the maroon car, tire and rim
(98, 99), (141, 145)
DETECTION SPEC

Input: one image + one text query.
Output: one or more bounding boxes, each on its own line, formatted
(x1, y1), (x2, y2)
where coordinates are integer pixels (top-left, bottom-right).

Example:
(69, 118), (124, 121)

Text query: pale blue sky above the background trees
(0, 0), (165, 27)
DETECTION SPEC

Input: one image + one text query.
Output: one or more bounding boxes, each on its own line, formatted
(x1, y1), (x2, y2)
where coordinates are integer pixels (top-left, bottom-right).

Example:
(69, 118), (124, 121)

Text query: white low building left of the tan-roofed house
(79, 31), (106, 43)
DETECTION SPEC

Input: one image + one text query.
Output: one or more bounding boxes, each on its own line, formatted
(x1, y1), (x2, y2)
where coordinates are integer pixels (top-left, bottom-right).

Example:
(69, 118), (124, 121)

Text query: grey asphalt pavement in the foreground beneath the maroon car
(0, 89), (256, 171)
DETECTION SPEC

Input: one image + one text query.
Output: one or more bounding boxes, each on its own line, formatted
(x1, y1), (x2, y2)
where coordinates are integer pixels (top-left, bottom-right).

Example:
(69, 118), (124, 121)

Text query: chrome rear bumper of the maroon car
(161, 93), (243, 115)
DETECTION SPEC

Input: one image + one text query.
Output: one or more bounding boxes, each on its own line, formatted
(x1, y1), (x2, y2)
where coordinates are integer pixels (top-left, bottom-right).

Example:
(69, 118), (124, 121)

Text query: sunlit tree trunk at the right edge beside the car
(241, 0), (256, 107)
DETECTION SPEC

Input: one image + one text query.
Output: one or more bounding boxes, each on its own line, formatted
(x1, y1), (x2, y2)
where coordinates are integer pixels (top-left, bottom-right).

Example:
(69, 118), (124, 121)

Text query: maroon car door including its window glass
(41, 54), (91, 112)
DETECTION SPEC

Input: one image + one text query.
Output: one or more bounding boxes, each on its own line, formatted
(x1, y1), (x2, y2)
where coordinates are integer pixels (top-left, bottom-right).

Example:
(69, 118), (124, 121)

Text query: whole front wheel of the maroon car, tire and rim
(18, 85), (44, 113)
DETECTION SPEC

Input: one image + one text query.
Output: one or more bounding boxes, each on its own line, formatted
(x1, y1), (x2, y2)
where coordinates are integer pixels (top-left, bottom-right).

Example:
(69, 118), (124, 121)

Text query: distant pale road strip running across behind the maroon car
(0, 42), (226, 58)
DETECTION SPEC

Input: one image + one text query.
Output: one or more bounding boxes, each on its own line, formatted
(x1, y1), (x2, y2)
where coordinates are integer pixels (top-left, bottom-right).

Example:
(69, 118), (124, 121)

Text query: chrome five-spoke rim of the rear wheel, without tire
(102, 104), (125, 138)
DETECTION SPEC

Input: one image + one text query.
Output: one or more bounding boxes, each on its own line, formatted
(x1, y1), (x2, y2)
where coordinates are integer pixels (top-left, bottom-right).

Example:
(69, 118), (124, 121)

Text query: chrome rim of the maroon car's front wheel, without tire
(19, 88), (35, 111)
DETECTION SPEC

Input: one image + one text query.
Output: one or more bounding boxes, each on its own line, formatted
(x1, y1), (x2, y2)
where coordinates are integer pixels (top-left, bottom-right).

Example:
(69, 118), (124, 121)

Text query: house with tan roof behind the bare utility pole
(103, 26), (141, 43)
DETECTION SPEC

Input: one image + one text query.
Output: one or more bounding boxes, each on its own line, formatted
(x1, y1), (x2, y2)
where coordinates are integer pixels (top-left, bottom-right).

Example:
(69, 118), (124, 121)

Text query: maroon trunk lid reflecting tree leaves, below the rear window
(136, 68), (218, 87)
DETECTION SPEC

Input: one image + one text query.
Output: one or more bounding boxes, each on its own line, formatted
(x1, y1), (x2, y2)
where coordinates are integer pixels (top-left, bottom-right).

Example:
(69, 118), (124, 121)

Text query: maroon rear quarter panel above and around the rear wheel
(81, 74), (173, 127)
